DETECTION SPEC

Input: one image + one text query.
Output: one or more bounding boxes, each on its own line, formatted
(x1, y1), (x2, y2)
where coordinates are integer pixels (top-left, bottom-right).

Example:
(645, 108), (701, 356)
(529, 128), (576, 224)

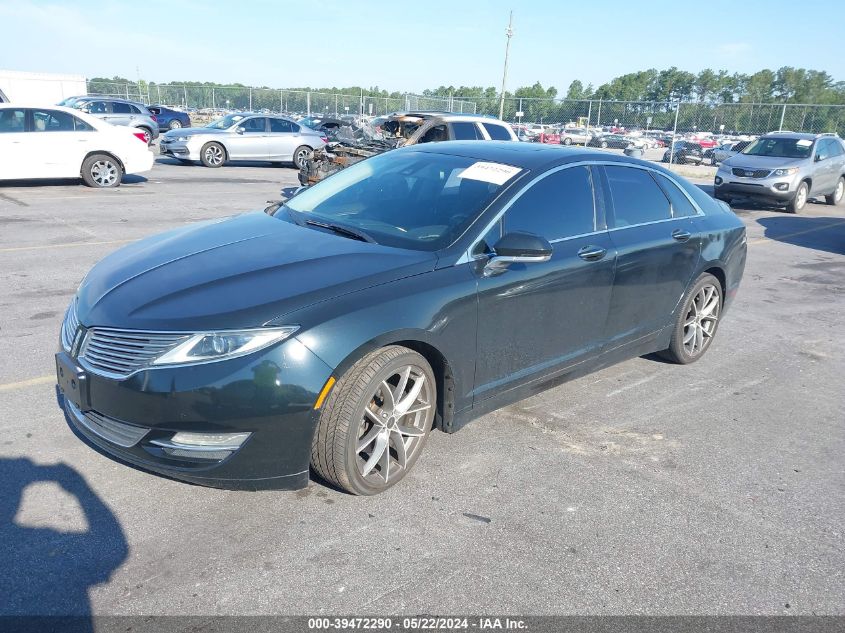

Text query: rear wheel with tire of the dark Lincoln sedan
(660, 273), (724, 365)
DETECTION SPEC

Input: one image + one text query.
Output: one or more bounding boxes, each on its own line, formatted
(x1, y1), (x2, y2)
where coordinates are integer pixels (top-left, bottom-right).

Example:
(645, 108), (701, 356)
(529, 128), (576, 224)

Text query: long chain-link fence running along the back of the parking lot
(81, 81), (845, 136)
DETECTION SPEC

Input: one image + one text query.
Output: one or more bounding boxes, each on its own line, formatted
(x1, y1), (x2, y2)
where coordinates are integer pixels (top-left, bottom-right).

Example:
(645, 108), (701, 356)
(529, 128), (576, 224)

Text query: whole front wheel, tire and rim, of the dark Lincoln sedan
(311, 345), (437, 495)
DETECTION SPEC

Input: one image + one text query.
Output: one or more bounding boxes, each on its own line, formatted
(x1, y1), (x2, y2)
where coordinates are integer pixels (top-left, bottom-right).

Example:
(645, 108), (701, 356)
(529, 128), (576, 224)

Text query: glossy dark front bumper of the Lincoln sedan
(57, 338), (331, 490)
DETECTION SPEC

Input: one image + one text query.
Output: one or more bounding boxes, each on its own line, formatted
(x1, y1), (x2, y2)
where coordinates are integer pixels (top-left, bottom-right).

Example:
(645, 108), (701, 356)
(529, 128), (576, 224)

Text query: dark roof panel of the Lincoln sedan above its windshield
(396, 141), (665, 171)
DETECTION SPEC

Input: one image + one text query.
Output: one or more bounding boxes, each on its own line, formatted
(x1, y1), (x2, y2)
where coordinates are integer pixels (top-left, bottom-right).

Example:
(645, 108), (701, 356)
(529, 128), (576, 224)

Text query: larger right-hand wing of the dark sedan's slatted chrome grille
(79, 328), (190, 378)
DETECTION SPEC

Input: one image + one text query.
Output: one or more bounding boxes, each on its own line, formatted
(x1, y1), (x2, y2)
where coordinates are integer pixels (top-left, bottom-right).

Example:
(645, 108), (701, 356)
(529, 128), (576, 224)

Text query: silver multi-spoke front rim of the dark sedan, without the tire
(356, 365), (434, 488)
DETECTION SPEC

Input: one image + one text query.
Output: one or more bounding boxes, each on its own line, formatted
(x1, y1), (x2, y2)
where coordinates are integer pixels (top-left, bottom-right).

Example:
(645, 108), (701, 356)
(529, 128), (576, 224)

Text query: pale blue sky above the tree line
(0, 0), (845, 92)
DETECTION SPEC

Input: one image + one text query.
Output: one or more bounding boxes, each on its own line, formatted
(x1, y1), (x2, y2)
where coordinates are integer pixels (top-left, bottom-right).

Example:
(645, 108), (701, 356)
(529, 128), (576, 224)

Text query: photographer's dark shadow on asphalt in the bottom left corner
(0, 457), (129, 631)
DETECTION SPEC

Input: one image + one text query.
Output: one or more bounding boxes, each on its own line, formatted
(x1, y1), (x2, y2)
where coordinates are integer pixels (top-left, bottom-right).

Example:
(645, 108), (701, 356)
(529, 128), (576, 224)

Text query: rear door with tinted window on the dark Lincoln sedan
(602, 165), (701, 348)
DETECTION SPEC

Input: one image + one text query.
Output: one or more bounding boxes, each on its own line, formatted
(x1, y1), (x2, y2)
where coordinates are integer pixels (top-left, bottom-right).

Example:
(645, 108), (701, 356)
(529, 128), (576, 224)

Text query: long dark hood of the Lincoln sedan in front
(78, 212), (437, 331)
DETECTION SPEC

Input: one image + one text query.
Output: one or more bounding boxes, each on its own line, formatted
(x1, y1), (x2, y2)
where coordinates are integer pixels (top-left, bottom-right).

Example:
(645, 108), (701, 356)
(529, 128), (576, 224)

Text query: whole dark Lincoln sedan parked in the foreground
(56, 142), (746, 495)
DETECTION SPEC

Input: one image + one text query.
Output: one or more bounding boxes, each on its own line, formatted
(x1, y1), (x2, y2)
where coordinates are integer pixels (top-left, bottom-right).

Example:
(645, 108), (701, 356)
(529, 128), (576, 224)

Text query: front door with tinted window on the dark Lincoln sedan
(474, 166), (616, 402)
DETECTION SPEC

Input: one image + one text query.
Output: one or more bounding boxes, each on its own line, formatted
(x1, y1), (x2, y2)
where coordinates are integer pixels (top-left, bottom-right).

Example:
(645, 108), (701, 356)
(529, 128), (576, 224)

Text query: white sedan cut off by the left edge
(0, 103), (155, 188)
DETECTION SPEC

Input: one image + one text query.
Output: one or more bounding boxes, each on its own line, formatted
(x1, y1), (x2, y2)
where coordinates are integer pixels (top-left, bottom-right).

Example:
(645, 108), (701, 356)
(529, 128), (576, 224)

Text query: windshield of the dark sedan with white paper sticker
(275, 150), (522, 251)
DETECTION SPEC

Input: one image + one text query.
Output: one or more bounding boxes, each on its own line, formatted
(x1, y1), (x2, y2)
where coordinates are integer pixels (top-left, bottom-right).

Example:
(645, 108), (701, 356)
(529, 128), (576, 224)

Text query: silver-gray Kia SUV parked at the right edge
(713, 132), (845, 213)
